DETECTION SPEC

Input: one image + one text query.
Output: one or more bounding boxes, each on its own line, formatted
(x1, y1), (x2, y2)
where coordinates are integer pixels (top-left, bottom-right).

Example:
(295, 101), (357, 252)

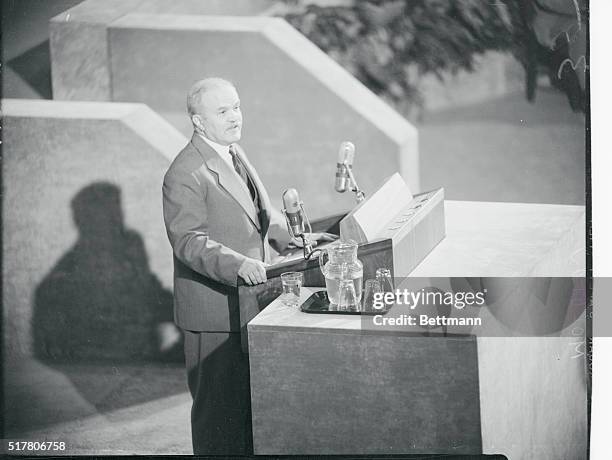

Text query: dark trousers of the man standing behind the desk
(184, 331), (253, 455)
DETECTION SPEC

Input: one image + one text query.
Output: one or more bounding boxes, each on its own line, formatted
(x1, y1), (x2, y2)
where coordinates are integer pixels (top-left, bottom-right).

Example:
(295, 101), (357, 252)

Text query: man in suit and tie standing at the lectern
(163, 78), (324, 454)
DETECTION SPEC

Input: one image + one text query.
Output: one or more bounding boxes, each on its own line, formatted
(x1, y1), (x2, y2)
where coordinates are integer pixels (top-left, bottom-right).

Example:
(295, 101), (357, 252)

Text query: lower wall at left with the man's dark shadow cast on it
(2, 99), (186, 359)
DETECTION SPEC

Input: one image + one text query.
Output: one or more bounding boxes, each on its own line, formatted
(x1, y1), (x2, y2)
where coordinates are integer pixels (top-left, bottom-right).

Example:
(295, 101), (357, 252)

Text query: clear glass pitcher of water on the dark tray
(319, 240), (363, 305)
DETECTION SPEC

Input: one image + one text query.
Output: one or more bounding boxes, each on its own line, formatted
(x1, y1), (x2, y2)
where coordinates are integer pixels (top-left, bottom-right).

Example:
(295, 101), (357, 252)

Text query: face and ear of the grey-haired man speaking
(193, 86), (242, 145)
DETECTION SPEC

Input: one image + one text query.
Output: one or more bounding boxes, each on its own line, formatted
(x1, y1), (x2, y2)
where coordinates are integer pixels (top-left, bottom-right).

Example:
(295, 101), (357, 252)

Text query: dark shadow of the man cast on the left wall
(33, 182), (182, 363)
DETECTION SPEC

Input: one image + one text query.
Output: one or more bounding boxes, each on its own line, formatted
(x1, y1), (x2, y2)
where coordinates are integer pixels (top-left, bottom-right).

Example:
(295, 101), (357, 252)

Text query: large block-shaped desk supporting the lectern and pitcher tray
(248, 201), (587, 459)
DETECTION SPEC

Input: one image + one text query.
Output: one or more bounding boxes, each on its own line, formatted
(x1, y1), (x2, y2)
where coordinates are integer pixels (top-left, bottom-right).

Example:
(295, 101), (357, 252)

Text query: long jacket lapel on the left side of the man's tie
(191, 134), (261, 230)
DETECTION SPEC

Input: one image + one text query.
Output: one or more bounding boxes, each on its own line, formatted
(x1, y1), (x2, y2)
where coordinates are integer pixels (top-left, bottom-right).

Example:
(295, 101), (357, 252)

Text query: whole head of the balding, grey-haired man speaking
(187, 78), (242, 145)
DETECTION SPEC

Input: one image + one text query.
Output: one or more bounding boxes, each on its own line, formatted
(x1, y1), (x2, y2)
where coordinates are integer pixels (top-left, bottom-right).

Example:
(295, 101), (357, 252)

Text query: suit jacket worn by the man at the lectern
(163, 134), (289, 332)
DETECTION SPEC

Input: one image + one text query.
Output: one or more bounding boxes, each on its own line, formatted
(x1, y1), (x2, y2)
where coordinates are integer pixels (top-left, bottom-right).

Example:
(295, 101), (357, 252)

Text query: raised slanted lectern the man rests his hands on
(238, 173), (445, 352)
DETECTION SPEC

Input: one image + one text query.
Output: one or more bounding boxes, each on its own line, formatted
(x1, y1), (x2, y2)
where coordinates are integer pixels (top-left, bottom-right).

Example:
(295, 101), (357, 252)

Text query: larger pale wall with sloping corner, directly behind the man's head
(51, 13), (419, 217)
